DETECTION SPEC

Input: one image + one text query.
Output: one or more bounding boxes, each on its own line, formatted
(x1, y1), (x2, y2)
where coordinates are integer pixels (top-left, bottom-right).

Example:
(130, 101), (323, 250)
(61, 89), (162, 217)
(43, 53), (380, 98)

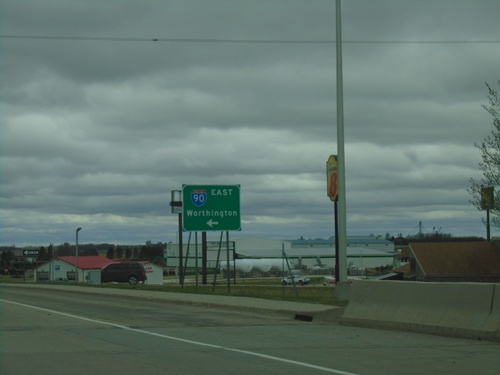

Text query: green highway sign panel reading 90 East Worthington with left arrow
(182, 185), (241, 232)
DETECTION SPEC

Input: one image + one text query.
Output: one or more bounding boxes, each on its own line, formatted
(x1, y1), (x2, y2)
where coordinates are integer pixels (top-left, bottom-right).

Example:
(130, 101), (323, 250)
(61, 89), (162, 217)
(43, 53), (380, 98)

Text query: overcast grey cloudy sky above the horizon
(0, 0), (500, 246)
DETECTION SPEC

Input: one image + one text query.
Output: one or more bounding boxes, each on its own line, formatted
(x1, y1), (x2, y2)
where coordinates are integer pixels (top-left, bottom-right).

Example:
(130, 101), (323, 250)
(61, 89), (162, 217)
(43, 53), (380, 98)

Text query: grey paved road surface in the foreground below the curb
(0, 284), (500, 375)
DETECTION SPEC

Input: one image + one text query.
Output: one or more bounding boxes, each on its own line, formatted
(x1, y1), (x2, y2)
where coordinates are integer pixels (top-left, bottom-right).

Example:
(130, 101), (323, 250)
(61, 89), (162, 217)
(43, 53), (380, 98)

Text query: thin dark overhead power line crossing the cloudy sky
(0, 35), (500, 44)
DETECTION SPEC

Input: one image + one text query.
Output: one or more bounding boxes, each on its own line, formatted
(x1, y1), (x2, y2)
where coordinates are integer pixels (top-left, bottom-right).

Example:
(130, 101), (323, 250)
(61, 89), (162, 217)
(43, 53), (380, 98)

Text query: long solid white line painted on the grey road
(0, 298), (360, 375)
